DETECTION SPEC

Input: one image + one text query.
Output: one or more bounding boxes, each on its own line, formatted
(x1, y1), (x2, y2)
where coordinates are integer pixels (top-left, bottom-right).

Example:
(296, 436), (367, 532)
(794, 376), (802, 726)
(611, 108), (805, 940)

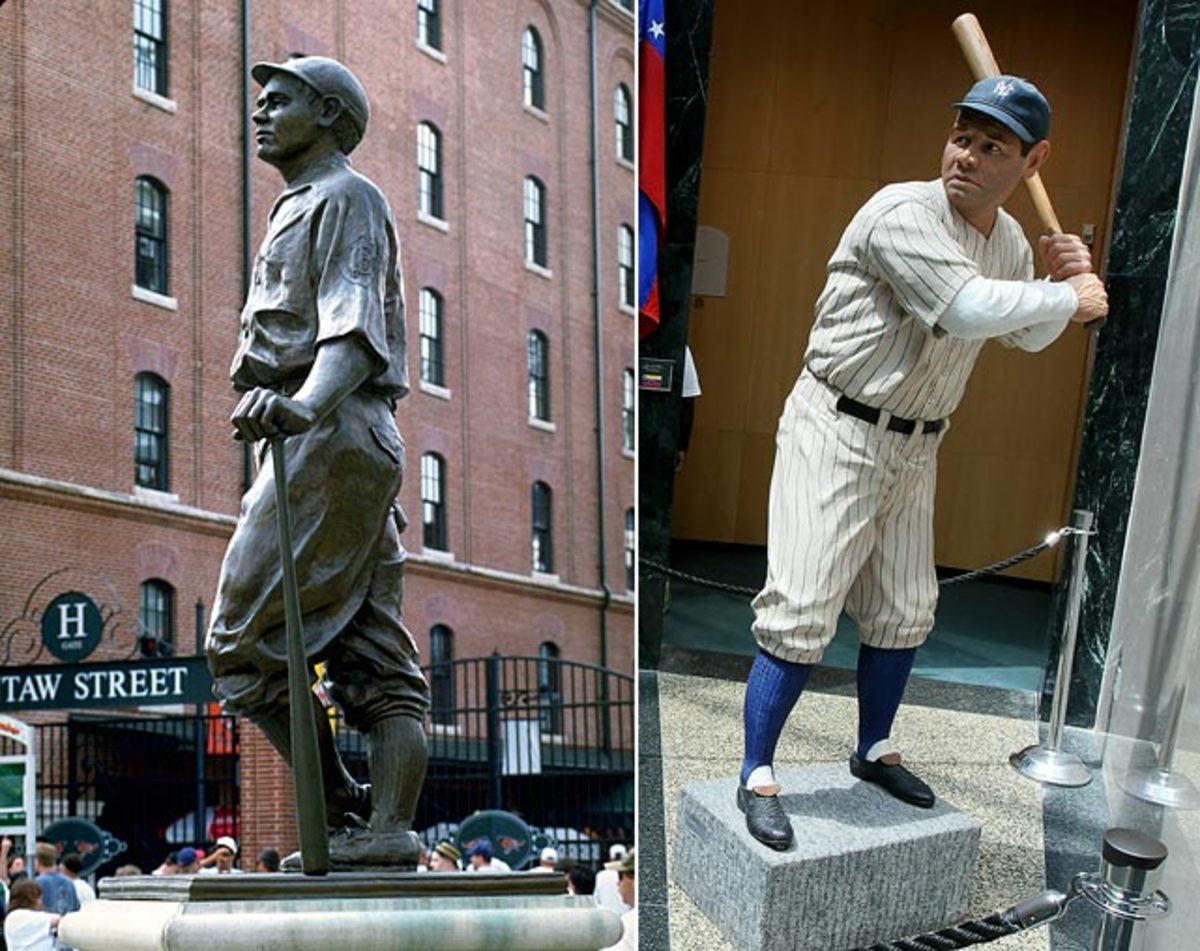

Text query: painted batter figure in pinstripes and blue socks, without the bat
(737, 76), (1108, 850)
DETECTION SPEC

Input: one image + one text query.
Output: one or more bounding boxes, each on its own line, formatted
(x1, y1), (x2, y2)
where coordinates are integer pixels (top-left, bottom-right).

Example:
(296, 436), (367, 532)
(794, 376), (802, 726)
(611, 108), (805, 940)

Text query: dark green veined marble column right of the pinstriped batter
(1043, 0), (1200, 725)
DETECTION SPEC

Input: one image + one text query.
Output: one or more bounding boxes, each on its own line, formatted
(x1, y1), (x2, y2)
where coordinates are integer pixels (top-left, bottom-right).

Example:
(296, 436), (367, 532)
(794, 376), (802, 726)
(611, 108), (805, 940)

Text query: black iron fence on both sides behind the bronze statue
(28, 654), (635, 875)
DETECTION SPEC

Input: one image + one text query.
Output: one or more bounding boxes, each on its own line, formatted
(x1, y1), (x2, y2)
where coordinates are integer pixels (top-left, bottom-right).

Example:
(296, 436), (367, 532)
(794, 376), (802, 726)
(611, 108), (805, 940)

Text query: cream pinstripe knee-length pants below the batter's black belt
(751, 370), (947, 664)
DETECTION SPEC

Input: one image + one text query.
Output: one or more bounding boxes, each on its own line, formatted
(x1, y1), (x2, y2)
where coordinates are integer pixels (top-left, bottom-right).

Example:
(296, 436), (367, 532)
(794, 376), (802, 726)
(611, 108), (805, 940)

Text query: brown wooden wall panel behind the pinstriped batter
(673, 0), (1136, 579)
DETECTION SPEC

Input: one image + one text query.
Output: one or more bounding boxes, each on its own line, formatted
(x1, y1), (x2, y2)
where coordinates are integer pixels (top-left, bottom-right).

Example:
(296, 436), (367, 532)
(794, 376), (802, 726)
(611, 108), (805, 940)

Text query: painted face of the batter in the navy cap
(942, 114), (1050, 227)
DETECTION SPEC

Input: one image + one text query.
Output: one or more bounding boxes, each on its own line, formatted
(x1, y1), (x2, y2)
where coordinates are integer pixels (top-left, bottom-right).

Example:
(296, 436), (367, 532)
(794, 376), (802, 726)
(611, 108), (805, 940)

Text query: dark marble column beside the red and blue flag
(637, 0), (716, 668)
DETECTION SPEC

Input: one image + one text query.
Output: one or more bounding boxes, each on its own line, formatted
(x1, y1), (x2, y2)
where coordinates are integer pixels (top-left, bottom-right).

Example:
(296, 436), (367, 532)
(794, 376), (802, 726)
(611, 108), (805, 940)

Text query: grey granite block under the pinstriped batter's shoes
(673, 764), (979, 951)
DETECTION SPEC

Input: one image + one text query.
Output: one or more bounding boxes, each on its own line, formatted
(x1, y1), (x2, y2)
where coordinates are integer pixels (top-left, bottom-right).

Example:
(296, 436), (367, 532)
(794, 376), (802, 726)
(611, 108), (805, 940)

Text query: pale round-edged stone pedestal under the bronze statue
(59, 873), (622, 951)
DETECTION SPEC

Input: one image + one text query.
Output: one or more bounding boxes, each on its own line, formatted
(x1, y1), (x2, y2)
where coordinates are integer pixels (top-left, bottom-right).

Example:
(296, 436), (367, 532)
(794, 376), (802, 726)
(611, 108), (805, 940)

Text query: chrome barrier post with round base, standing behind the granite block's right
(1008, 509), (1093, 786)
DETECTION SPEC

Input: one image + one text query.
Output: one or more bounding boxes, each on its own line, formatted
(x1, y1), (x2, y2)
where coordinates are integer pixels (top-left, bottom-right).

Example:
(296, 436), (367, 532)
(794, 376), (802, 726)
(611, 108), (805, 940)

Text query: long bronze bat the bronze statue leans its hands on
(271, 436), (329, 875)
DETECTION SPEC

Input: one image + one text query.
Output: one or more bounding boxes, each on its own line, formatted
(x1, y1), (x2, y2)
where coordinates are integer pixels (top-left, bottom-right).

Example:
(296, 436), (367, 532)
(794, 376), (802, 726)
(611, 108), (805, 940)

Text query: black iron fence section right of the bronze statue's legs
(338, 654), (635, 862)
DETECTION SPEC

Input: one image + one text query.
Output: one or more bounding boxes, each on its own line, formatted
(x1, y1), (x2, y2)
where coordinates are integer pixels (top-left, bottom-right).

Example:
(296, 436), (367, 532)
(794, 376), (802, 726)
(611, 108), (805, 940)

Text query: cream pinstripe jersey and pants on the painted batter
(752, 180), (1033, 663)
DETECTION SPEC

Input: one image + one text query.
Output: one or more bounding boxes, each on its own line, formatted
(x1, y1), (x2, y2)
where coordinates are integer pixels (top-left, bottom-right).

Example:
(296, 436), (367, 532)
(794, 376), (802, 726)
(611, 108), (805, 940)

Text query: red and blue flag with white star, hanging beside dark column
(637, 0), (667, 337)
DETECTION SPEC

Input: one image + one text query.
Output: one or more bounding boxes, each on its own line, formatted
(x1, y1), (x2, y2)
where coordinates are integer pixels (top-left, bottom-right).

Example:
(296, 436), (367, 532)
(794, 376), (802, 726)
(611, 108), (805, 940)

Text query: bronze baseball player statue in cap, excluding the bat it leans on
(208, 56), (428, 869)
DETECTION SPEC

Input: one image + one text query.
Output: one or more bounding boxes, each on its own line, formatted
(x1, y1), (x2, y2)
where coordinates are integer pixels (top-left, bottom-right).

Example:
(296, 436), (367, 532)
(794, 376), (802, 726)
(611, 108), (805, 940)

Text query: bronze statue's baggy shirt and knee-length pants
(208, 156), (428, 729)
